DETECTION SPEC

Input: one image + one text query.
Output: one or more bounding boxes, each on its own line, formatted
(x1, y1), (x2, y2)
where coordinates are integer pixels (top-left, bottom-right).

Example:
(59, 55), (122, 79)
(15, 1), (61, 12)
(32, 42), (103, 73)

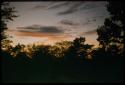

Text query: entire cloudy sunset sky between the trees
(6, 1), (109, 46)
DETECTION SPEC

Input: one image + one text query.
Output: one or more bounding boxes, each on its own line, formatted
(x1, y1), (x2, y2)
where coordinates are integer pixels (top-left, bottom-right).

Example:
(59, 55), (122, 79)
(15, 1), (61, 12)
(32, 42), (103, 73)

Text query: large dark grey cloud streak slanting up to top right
(57, 1), (105, 15)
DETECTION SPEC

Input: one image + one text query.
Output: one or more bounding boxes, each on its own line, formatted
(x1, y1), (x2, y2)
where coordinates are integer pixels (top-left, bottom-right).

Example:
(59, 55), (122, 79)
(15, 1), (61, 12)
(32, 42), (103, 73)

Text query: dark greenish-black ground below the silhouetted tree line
(2, 58), (124, 83)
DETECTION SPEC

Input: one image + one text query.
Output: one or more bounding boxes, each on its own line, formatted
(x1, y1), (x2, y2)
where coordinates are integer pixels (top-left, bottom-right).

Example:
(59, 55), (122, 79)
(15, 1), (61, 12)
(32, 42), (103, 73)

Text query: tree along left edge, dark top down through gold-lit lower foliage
(0, 2), (17, 64)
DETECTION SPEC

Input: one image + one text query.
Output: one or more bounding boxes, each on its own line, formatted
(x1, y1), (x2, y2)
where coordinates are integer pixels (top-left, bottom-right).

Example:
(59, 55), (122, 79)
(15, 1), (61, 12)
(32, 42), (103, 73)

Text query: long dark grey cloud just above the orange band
(17, 25), (64, 33)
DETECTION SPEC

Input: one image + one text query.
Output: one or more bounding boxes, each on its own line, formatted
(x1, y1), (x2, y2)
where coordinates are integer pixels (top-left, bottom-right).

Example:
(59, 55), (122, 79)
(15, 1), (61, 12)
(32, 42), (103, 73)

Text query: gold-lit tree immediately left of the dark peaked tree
(49, 41), (72, 63)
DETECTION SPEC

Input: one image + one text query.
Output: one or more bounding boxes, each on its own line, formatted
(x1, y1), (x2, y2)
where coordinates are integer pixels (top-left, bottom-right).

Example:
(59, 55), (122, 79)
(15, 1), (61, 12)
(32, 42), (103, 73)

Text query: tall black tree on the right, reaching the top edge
(97, 1), (124, 54)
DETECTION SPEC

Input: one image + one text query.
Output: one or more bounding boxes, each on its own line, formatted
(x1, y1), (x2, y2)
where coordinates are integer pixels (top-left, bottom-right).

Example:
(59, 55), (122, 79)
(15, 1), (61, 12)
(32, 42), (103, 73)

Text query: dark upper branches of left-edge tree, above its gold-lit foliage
(0, 2), (17, 39)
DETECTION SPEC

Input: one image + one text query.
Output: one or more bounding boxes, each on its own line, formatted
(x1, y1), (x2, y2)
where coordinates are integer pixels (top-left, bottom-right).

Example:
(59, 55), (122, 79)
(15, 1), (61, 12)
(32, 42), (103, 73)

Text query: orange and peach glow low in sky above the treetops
(6, 30), (98, 47)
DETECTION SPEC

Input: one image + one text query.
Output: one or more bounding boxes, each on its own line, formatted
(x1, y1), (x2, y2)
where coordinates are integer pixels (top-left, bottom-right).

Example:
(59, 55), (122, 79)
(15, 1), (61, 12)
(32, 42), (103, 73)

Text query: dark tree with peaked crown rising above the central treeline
(65, 37), (93, 62)
